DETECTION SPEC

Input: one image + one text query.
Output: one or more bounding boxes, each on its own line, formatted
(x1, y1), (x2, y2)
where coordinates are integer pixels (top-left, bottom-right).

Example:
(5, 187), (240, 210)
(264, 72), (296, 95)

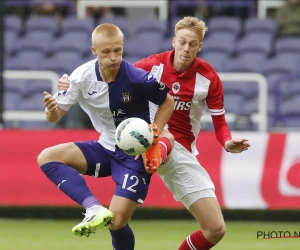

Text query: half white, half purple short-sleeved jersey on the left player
(55, 60), (169, 151)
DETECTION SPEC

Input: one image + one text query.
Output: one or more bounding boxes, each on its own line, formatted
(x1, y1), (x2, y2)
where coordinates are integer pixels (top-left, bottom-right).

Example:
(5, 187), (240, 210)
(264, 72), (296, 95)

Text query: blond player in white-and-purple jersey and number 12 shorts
(38, 24), (174, 250)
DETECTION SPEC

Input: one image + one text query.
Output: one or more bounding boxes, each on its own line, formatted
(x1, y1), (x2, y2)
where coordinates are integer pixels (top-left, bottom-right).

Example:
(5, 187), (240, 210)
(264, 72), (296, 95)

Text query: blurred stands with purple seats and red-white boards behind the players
(0, 0), (300, 250)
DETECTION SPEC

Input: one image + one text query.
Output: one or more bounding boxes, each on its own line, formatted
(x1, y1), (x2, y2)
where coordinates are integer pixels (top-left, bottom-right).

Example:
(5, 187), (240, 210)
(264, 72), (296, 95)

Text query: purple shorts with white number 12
(75, 141), (152, 204)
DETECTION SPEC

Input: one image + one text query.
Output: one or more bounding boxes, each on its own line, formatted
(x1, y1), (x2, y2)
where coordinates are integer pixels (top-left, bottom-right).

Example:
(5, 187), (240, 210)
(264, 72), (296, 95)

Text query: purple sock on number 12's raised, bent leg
(41, 162), (99, 205)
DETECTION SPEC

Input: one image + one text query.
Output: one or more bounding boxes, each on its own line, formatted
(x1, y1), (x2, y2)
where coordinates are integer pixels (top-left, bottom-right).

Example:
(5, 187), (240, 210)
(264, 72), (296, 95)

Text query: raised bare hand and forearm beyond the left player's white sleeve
(44, 91), (66, 122)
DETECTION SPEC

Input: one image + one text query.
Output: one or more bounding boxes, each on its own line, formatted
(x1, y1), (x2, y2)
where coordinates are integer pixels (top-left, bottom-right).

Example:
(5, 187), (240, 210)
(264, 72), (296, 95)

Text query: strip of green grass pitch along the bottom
(0, 219), (300, 250)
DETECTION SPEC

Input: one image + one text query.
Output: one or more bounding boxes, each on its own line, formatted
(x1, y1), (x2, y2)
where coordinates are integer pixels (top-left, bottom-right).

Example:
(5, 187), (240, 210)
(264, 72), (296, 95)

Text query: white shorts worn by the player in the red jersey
(157, 142), (216, 209)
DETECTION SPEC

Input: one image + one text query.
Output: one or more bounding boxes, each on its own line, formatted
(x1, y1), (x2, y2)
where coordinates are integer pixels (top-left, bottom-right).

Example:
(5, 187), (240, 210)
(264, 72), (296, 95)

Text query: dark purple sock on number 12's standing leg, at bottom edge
(109, 224), (135, 250)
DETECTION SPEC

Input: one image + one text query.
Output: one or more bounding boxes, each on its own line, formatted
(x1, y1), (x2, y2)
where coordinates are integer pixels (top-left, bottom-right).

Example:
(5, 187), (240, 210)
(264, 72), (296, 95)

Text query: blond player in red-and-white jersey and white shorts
(58, 17), (250, 250)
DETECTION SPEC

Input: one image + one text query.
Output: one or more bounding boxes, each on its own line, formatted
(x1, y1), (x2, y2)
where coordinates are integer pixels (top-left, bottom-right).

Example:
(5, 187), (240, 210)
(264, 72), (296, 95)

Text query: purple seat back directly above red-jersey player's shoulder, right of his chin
(199, 51), (230, 72)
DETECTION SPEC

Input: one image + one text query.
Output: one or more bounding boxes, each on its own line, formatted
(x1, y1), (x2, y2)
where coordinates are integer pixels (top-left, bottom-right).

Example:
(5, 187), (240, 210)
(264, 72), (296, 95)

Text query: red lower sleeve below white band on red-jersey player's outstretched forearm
(212, 114), (232, 147)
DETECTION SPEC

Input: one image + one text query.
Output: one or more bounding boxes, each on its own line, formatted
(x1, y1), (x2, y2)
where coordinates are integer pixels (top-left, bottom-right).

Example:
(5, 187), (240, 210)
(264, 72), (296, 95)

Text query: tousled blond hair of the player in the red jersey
(174, 16), (207, 42)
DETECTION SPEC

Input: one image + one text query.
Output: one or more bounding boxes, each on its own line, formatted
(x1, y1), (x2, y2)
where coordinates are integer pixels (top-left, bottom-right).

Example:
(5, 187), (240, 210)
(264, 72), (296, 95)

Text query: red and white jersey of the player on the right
(134, 50), (231, 154)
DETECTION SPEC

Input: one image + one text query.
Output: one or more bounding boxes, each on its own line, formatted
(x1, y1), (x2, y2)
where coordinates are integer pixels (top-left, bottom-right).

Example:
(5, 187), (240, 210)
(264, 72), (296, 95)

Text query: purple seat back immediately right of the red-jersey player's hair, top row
(207, 16), (242, 37)
